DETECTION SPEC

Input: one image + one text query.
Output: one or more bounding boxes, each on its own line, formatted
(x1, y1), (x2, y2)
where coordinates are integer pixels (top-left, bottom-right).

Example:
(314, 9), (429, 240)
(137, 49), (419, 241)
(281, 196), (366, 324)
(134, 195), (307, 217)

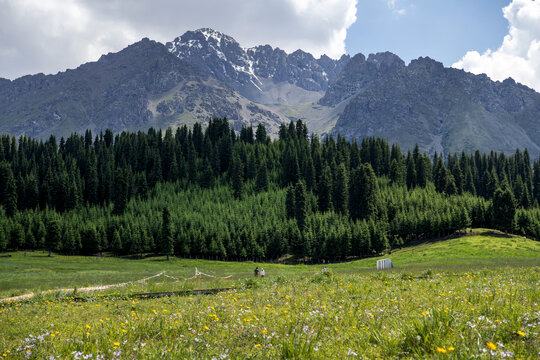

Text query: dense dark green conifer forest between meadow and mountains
(0, 118), (540, 261)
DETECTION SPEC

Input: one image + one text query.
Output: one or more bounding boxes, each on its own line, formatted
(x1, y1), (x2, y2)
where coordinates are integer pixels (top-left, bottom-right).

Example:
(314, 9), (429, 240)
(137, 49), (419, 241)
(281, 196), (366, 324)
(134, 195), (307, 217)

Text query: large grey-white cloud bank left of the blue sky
(0, 0), (358, 79)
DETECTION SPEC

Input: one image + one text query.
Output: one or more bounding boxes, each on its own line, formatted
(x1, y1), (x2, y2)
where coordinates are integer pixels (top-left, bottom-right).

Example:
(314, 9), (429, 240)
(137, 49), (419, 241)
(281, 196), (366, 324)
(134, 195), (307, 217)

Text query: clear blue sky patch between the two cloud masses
(345, 0), (510, 66)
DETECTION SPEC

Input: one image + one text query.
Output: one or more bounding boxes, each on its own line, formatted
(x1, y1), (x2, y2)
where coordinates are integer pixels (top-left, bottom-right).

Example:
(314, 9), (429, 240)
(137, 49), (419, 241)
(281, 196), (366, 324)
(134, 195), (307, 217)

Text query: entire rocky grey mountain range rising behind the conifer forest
(0, 29), (540, 155)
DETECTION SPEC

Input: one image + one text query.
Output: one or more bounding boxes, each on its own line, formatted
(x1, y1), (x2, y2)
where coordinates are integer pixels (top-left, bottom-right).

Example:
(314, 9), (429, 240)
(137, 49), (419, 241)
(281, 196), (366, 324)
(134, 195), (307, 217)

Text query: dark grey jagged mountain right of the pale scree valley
(326, 55), (540, 154)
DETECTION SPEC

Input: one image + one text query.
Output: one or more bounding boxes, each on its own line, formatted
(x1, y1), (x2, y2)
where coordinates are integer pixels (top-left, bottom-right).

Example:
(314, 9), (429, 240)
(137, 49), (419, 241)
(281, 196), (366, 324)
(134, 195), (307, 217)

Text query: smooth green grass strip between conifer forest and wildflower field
(0, 229), (540, 298)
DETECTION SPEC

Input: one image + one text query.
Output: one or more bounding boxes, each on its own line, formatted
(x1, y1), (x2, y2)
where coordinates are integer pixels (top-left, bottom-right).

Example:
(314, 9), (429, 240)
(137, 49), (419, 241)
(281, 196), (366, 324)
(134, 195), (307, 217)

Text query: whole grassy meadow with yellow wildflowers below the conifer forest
(0, 229), (540, 359)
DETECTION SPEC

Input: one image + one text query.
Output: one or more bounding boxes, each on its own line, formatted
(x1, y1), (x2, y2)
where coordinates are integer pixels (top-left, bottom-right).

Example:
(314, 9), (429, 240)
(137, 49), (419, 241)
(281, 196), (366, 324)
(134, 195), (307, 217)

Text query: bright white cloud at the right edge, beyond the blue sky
(452, 0), (540, 91)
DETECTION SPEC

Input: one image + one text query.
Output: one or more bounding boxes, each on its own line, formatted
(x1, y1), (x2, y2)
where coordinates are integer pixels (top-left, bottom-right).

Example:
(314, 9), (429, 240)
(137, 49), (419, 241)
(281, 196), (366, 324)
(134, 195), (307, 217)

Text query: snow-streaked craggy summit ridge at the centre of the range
(166, 29), (349, 100)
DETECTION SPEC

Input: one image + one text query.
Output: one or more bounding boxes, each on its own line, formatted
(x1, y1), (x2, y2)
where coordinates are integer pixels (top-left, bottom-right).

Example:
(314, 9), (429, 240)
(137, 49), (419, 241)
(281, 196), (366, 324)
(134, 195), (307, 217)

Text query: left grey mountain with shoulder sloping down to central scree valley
(0, 39), (292, 137)
